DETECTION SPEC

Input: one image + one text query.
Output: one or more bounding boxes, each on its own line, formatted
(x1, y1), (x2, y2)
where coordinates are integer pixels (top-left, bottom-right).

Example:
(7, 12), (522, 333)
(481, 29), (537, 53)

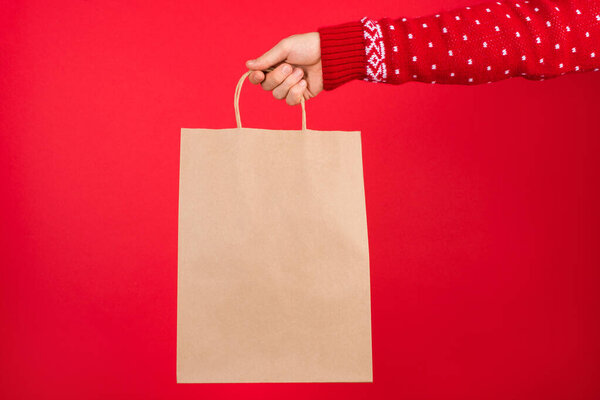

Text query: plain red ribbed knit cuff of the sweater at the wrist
(318, 21), (367, 90)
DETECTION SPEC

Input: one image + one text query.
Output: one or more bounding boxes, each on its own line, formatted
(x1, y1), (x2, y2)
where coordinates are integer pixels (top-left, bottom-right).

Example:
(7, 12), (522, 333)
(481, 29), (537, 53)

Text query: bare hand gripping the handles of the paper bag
(246, 32), (323, 106)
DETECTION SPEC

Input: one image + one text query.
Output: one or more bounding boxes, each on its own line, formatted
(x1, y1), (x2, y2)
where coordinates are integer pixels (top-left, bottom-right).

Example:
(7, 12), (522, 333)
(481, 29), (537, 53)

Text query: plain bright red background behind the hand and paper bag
(0, 0), (600, 400)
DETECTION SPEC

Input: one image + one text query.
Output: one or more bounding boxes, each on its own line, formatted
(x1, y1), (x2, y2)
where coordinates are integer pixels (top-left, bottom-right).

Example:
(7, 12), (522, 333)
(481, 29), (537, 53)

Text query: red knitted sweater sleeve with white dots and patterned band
(319, 0), (600, 90)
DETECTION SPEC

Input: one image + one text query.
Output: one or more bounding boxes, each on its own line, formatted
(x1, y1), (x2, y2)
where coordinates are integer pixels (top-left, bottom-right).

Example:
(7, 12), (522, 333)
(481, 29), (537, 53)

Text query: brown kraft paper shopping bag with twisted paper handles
(177, 73), (372, 383)
